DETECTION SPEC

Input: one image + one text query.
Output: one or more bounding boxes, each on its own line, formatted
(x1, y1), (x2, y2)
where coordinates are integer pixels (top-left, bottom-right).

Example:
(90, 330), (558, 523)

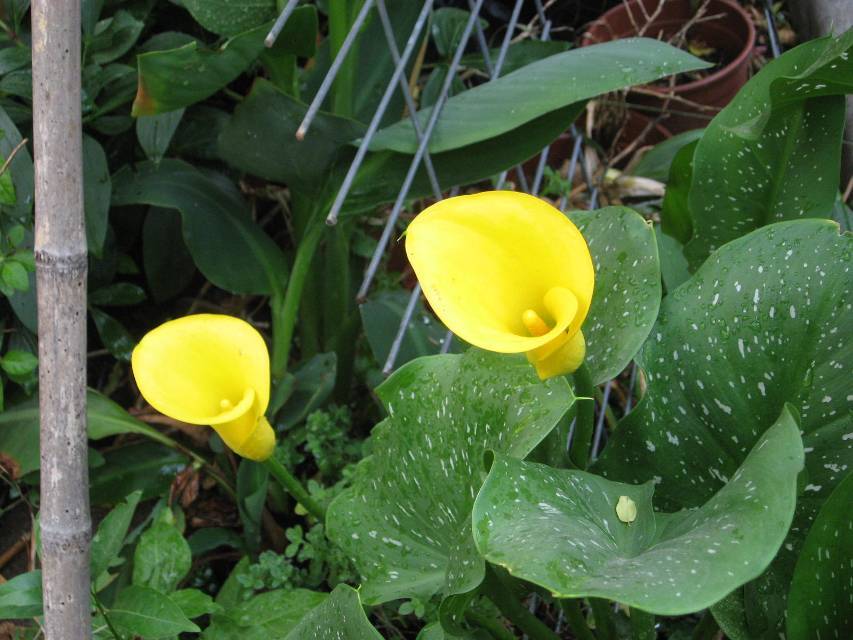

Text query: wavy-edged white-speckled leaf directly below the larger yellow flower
(327, 349), (574, 604)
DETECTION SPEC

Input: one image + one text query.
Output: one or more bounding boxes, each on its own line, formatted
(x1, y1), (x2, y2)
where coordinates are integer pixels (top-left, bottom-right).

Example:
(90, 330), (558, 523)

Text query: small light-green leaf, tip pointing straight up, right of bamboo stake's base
(133, 507), (192, 594)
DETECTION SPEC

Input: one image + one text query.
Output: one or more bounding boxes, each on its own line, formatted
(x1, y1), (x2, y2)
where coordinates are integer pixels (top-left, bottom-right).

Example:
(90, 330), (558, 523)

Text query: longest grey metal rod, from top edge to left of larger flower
(357, 0), (483, 300)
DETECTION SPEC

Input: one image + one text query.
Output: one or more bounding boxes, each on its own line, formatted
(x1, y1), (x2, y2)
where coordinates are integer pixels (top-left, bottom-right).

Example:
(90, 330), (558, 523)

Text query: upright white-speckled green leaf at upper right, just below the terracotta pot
(685, 30), (853, 268)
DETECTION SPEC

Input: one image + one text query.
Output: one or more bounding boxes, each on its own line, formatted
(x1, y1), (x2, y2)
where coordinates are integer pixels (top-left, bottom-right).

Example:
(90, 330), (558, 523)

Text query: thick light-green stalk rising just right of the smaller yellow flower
(270, 222), (325, 378)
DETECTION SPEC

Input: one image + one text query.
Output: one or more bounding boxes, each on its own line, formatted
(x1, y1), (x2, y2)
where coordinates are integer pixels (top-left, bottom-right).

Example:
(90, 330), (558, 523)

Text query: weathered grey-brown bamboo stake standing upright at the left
(31, 0), (91, 640)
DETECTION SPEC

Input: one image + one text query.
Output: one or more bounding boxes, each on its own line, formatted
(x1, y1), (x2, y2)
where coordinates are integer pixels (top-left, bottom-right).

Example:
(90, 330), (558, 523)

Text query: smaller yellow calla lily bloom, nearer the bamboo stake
(131, 314), (275, 461)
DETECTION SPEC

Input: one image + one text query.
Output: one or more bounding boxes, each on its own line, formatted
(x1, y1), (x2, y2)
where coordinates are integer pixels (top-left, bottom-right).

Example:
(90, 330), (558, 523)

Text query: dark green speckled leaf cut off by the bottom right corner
(786, 471), (853, 640)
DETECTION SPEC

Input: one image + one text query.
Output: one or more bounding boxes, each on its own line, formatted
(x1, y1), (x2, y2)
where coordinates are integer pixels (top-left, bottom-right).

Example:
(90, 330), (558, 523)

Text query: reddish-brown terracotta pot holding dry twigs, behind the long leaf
(581, 0), (755, 133)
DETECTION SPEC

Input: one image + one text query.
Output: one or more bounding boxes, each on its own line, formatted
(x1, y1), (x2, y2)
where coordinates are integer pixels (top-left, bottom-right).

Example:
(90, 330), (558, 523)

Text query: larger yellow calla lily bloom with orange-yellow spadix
(406, 191), (595, 380)
